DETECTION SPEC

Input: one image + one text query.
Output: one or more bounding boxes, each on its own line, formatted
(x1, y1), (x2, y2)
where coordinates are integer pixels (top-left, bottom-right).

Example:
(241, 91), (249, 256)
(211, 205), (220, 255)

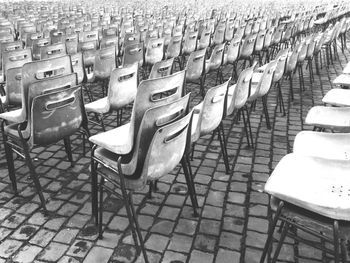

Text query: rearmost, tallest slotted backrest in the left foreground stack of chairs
(21, 56), (73, 120)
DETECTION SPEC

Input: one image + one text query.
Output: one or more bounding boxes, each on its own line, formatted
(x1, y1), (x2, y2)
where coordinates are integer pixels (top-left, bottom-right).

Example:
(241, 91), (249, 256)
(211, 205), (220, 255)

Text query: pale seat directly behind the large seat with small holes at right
(293, 131), (350, 160)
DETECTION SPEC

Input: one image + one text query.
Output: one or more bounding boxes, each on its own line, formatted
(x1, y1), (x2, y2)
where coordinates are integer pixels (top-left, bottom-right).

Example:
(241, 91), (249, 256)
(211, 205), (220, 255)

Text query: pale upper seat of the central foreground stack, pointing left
(89, 123), (134, 154)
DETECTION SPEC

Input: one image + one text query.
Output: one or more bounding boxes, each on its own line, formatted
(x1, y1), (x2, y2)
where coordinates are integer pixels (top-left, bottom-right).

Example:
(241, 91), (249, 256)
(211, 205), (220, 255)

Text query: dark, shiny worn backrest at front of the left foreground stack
(28, 87), (87, 145)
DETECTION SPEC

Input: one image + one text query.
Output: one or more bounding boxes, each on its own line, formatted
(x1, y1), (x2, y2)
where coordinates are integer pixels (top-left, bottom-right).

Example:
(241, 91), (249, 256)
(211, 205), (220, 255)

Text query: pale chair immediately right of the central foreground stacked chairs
(191, 79), (230, 174)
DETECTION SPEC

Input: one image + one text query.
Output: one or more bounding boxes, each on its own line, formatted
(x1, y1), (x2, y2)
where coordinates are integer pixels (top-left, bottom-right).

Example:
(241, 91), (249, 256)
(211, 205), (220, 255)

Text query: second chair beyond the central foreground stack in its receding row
(226, 62), (257, 147)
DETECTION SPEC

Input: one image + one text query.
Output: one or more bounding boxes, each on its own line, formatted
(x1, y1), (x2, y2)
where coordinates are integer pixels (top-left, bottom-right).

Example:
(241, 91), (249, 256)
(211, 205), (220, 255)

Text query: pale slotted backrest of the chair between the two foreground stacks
(108, 63), (138, 110)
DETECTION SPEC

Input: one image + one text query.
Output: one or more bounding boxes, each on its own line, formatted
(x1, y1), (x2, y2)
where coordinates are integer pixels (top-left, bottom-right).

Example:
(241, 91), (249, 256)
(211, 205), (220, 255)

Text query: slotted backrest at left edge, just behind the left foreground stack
(2, 48), (32, 73)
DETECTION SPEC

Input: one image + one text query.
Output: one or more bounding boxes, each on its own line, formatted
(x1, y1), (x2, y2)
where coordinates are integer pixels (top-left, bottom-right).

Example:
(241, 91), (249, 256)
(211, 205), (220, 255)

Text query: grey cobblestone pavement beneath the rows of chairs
(0, 37), (350, 263)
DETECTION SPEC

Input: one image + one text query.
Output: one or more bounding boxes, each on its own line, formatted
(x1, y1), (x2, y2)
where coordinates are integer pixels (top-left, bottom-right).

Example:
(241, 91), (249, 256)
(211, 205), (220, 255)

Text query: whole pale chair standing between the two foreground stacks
(85, 63), (138, 131)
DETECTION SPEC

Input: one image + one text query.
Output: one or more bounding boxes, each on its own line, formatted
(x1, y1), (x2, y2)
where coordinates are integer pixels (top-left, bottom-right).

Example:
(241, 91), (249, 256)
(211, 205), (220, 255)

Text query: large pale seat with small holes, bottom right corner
(265, 154), (350, 221)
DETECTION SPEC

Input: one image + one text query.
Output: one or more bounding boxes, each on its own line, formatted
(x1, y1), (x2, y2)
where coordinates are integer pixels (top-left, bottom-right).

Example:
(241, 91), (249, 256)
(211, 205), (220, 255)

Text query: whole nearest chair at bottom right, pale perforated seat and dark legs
(260, 153), (350, 263)
